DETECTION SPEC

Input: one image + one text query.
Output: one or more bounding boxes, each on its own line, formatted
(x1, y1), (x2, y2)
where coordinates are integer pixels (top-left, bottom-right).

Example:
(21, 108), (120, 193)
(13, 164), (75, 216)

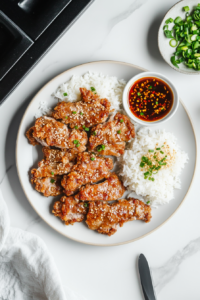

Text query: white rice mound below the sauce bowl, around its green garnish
(118, 127), (189, 207)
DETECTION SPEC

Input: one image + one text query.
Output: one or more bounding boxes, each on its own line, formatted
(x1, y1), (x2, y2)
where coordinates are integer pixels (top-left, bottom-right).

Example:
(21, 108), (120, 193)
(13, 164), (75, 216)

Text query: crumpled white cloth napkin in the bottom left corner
(0, 190), (84, 300)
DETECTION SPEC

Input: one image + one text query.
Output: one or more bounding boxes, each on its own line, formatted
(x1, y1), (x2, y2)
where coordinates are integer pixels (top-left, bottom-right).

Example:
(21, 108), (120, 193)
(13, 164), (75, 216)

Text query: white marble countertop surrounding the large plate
(0, 0), (200, 300)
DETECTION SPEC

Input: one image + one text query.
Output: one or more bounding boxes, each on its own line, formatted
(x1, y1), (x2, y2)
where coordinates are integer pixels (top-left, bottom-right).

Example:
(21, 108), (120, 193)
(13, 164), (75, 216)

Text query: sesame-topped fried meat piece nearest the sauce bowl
(89, 113), (135, 156)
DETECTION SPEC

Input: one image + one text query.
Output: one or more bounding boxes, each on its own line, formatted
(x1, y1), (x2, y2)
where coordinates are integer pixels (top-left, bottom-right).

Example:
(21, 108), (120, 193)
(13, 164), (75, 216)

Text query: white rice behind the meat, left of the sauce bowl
(53, 71), (126, 110)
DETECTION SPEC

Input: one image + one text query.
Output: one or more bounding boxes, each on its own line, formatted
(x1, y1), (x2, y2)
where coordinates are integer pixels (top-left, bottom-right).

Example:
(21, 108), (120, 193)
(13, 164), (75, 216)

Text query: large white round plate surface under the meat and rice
(16, 61), (197, 246)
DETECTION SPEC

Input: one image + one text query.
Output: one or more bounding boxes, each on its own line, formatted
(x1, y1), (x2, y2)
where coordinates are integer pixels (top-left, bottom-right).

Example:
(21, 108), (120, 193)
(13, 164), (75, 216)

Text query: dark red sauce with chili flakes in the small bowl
(129, 77), (174, 122)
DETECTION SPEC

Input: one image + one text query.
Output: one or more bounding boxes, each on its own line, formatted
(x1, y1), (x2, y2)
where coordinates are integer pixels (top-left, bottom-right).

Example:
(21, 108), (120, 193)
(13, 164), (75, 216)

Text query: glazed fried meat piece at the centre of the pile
(61, 152), (113, 196)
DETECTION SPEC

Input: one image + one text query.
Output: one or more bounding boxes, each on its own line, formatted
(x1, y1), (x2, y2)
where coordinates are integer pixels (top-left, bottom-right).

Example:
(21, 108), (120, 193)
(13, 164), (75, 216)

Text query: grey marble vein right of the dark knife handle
(151, 237), (200, 294)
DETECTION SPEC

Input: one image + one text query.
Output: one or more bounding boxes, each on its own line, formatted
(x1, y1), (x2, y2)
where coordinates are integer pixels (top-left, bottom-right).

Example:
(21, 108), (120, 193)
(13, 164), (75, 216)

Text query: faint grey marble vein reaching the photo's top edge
(94, 0), (148, 51)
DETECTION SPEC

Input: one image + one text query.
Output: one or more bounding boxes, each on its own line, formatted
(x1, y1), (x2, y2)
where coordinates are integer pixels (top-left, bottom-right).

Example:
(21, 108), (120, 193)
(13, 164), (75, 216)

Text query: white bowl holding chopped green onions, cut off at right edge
(158, 0), (200, 75)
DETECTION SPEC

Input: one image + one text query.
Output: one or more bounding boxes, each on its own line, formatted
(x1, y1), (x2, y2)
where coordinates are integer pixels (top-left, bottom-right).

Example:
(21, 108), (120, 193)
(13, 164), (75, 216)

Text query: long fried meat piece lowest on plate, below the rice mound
(86, 198), (151, 236)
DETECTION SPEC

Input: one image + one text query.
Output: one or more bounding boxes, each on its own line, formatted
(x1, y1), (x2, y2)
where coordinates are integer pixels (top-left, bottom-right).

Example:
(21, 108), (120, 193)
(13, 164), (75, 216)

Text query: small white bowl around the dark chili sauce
(123, 72), (179, 126)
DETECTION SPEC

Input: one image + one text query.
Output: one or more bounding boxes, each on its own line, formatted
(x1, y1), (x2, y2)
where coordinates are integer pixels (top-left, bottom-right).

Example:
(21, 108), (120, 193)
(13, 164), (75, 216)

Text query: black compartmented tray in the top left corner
(0, 0), (94, 104)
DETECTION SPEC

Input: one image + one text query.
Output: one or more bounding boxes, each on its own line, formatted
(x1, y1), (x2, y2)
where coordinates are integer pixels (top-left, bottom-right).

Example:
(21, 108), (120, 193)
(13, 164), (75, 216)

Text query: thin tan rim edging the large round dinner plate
(15, 60), (198, 247)
